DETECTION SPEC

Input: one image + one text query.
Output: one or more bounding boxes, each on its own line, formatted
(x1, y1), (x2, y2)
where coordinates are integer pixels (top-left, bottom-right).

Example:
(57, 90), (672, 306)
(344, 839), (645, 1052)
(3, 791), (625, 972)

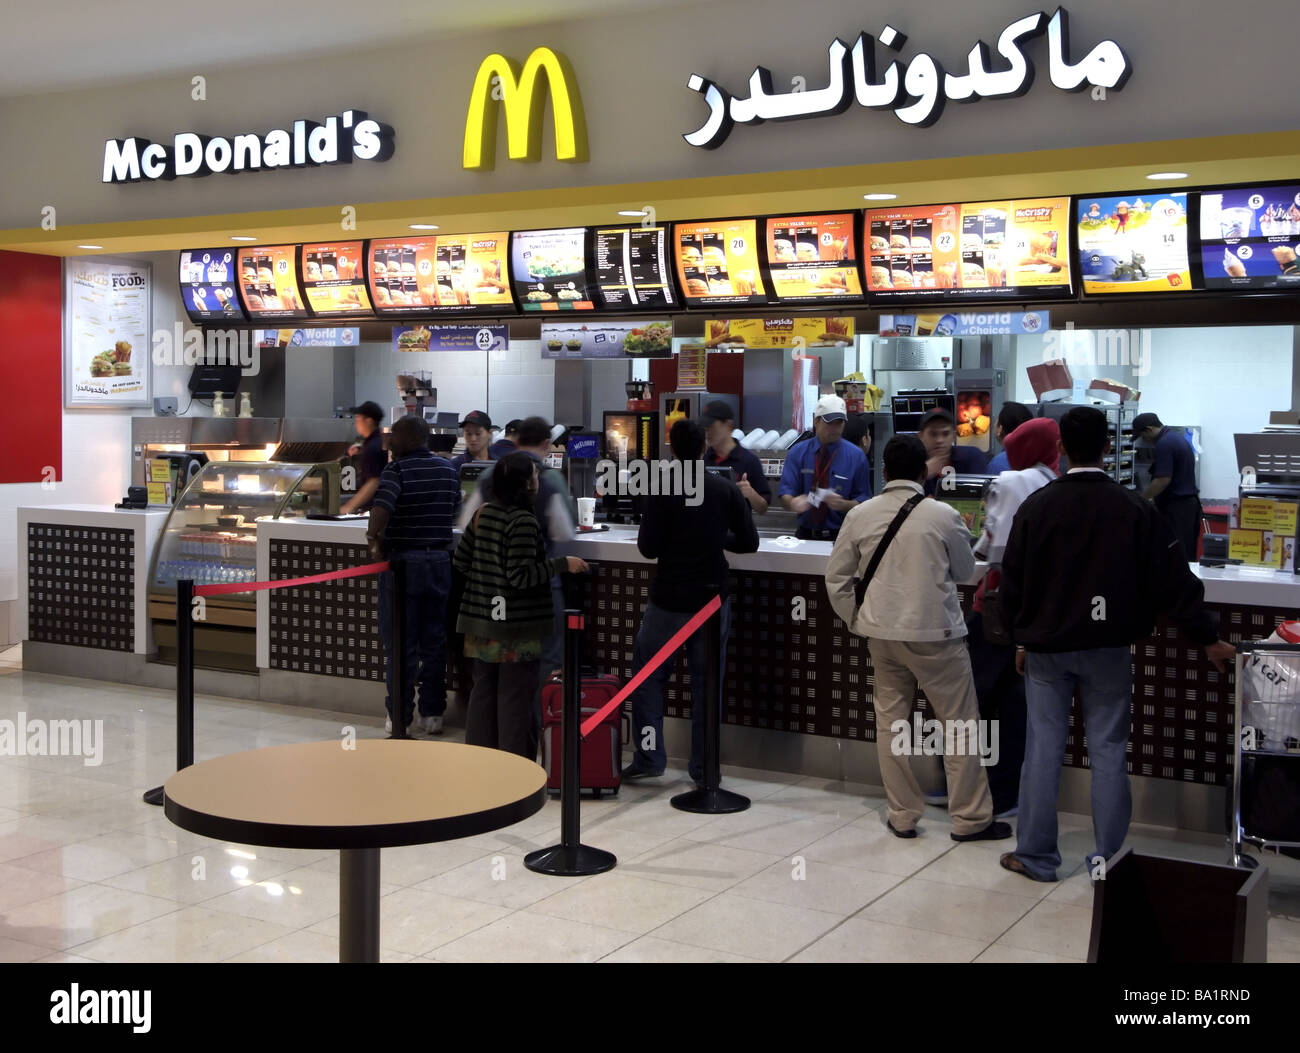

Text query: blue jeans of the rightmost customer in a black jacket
(1015, 647), (1132, 880)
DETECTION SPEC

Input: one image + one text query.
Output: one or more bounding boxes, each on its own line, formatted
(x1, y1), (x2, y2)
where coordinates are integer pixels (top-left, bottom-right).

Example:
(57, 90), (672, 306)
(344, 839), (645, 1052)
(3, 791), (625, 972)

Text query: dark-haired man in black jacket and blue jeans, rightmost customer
(1001, 406), (1236, 881)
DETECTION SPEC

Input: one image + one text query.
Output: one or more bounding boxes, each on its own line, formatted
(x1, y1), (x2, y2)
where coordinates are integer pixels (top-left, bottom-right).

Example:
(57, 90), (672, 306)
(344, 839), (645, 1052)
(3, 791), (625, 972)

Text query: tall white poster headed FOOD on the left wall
(64, 257), (153, 408)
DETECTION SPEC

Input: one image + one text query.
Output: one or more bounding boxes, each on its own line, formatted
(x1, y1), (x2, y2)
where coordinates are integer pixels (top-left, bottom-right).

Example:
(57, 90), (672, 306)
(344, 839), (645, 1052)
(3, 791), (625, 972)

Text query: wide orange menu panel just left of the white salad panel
(369, 230), (515, 316)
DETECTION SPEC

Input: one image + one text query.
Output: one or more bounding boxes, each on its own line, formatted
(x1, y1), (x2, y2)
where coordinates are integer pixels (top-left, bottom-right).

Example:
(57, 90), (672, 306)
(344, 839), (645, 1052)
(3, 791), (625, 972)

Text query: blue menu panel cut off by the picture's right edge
(1200, 185), (1300, 293)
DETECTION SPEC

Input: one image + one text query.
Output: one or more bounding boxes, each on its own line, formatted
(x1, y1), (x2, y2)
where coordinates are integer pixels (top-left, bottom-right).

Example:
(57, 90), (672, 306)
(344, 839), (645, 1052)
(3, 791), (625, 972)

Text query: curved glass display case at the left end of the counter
(150, 462), (339, 606)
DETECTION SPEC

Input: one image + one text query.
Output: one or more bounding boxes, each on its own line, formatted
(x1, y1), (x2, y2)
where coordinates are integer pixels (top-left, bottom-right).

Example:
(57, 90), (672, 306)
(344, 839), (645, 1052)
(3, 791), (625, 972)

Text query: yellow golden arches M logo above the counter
(463, 48), (588, 169)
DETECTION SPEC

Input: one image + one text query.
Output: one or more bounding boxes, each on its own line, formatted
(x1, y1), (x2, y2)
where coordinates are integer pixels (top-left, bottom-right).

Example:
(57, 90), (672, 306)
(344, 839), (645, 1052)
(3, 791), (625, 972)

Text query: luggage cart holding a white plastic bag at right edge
(1229, 641), (1300, 870)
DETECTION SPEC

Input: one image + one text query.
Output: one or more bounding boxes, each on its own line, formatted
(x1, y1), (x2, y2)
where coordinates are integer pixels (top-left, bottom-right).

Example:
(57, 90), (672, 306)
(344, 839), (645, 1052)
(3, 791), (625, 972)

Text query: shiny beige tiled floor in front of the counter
(0, 639), (1300, 962)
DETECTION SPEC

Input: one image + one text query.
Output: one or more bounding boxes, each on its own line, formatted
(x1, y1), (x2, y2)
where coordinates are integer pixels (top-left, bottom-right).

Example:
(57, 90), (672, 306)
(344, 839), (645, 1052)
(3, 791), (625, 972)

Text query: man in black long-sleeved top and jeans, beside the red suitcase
(623, 420), (758, 784)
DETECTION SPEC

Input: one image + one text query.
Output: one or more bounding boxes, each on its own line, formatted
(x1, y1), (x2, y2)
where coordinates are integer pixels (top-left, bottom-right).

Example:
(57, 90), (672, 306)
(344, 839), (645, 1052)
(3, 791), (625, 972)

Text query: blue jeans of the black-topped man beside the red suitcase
(632, 598), (731, 780)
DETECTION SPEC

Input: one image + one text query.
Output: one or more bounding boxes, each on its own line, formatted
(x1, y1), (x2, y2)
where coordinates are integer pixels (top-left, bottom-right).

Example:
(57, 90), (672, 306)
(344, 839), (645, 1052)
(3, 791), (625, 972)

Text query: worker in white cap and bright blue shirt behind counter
(777, 395), (871, 541)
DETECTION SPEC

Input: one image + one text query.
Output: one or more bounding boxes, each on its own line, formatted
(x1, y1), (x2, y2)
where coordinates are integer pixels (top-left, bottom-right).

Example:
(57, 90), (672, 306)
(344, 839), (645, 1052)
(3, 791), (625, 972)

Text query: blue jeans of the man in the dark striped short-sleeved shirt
(380, 549), (451, 727)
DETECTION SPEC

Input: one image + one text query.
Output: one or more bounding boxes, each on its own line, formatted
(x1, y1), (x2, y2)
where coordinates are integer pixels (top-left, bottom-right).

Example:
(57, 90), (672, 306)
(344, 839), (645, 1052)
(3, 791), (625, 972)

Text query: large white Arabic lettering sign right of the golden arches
(683, 8), (1132, 143)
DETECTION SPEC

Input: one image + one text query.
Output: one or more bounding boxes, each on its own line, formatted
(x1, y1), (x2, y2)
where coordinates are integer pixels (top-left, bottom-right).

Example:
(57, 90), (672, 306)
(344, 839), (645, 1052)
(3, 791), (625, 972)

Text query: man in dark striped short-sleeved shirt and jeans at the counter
(365, 416), (460, 735)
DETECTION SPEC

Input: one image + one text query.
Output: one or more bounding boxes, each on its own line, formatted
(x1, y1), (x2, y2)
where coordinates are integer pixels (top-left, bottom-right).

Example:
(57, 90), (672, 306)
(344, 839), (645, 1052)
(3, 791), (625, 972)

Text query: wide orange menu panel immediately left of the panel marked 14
(866, 198), (1074, 303)
